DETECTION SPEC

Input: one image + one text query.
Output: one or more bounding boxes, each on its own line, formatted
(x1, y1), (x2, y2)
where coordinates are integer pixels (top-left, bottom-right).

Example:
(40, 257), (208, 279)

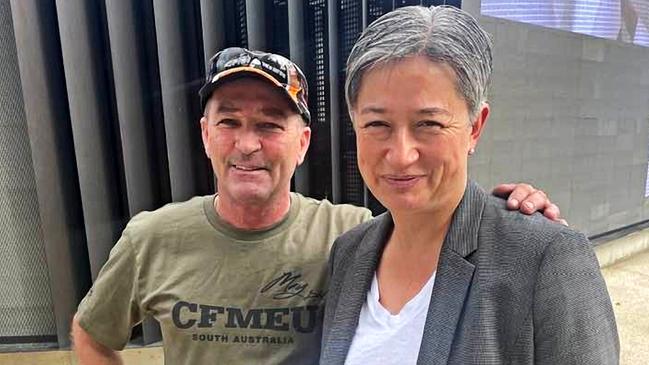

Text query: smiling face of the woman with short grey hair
(352, 56), (489, 214)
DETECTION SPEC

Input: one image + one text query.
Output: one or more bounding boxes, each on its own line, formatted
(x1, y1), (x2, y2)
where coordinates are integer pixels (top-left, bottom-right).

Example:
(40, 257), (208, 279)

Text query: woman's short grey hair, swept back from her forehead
(345, 6), (492, 120)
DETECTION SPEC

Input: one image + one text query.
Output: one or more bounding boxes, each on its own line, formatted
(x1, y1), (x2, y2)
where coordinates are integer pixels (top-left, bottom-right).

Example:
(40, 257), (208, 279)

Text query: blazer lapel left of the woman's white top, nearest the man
(322, 213), (393, 364)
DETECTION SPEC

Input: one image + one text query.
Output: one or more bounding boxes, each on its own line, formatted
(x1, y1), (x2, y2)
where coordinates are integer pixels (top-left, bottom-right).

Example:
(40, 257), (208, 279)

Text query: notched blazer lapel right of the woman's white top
(417, 181), (486, 365)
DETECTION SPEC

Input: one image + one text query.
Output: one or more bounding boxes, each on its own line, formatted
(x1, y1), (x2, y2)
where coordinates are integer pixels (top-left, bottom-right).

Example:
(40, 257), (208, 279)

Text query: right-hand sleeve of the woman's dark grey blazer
(533, 230), (620, 364)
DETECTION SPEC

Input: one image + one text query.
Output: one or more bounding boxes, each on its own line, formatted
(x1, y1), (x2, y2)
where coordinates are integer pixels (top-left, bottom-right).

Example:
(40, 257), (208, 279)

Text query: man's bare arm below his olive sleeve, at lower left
(71, 316), (123, 365)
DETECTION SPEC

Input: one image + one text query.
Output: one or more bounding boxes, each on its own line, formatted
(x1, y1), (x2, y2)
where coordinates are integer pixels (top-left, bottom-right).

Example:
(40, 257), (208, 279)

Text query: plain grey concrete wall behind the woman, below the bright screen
(463, 1), (649, 235)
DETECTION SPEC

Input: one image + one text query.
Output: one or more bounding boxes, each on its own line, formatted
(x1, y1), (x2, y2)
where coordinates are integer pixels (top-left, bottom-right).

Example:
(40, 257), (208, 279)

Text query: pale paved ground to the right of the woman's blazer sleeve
(602, 247), (649, 365)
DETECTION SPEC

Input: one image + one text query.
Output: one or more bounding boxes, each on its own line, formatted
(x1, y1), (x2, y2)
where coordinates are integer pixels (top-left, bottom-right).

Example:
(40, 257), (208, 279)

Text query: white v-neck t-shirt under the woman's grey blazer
(345, 273), (435, 365)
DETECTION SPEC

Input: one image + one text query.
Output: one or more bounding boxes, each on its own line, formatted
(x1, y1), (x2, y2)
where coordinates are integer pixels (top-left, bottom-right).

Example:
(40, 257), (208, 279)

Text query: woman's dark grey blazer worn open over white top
(320, 182), (619, 365)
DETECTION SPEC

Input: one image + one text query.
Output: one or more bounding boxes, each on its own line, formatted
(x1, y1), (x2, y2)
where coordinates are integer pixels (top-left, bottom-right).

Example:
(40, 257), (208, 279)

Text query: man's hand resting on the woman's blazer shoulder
(491, 183), (568, 226)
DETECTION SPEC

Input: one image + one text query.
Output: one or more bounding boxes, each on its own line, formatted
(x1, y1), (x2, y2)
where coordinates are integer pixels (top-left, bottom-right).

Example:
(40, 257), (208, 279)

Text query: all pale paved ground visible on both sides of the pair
(0, 251), (649, 365)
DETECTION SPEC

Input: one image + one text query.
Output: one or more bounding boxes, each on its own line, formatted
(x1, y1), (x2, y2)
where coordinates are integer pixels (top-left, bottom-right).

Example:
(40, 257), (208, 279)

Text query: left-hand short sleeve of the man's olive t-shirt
(77, 232), (143, 350)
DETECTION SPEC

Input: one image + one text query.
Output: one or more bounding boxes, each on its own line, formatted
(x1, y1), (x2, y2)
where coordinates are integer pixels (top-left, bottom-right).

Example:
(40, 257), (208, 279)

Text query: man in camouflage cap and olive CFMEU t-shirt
(73, 48), (558, 364)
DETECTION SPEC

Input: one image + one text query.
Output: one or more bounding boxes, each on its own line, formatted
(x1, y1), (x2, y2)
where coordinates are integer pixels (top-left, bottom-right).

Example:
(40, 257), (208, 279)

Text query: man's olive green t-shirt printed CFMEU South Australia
(77, 193), (371, 365)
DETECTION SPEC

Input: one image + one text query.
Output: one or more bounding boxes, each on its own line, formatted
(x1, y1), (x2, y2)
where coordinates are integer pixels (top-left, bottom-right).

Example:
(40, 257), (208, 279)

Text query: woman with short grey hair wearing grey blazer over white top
(321, 7), (619, 364)
